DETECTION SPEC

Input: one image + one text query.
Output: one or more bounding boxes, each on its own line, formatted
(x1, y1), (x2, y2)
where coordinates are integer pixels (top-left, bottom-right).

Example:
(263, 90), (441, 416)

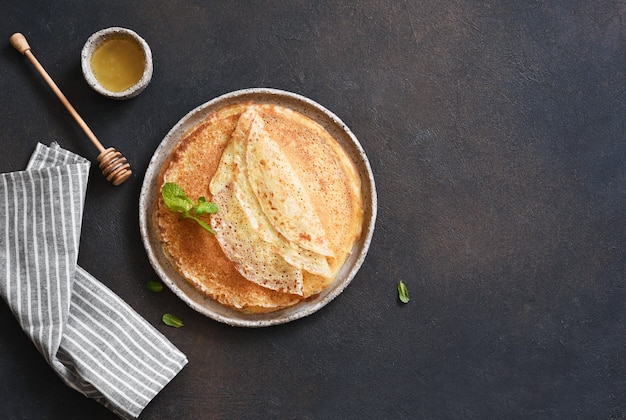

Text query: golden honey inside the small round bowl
(90, 37), (145, 92)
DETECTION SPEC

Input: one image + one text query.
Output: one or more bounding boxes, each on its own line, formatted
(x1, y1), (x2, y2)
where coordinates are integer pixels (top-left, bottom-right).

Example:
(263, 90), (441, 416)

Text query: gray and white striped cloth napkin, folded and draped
(0, 143), (187, 418)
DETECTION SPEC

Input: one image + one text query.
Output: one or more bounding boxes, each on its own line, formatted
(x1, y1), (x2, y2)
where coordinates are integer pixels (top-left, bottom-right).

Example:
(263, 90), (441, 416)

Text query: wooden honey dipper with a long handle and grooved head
(9, 33), (133, 185)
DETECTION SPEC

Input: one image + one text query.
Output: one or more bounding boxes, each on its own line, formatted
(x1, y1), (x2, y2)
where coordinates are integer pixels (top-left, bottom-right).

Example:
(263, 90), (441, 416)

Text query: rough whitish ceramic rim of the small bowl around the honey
(80, 27), (153, 99)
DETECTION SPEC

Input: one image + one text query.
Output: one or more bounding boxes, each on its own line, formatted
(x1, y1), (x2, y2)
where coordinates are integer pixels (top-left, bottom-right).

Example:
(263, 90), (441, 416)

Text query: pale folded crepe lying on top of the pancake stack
(209, 107), (332, 296)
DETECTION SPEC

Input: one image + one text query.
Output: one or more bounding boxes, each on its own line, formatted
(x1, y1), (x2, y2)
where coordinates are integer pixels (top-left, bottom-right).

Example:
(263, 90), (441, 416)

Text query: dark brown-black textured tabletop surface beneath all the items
(0, 0), (626, 419)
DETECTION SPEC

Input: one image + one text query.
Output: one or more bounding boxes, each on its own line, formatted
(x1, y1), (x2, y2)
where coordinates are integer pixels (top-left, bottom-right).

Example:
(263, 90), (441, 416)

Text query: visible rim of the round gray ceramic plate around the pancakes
(139, 89), (377, 327)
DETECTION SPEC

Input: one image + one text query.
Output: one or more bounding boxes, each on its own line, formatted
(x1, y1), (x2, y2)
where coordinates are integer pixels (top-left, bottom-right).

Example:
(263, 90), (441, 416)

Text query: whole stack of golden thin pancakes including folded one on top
(154, 103), (363, 313)
